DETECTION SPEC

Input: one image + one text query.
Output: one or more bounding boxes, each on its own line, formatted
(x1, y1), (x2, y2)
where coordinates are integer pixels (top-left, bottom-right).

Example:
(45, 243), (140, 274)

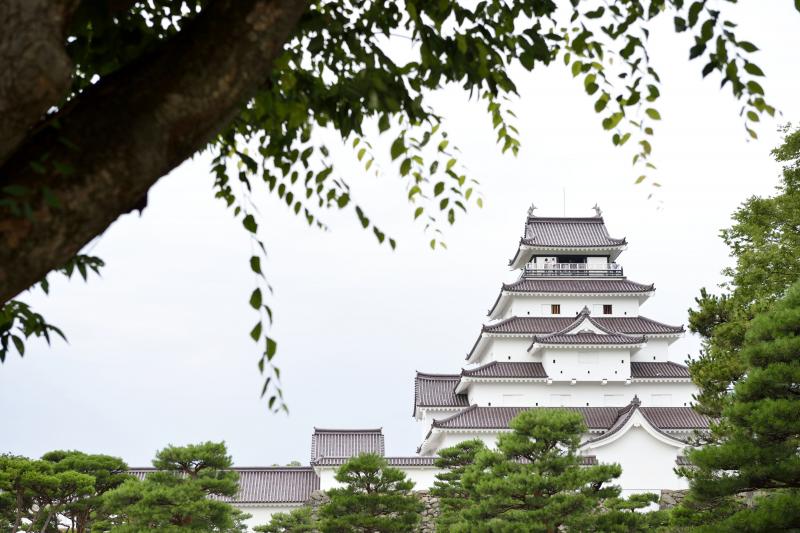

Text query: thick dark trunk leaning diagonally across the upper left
(0, 0), (307, 303)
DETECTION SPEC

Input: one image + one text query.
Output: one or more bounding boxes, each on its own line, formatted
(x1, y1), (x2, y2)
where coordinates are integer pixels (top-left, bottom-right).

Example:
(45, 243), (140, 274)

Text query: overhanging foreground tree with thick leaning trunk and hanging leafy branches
(0, 0), (788, 407)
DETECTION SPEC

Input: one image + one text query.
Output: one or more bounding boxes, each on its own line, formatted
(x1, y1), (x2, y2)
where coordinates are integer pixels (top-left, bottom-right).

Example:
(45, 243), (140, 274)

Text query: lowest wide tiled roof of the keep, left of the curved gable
(432, 405), (619, 430)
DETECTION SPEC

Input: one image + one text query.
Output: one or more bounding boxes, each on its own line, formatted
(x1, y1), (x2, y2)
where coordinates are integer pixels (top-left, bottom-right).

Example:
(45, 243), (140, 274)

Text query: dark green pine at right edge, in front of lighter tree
(683, 280), (800, 531)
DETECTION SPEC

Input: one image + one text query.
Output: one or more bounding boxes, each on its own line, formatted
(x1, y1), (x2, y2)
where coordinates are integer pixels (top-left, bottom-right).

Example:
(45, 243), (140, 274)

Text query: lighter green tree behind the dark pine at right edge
(689, 126), (800, 416)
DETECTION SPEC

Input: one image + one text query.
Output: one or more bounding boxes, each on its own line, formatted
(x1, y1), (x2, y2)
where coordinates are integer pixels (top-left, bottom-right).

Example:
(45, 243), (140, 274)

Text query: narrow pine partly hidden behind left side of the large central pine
(431, 439), (486, 531)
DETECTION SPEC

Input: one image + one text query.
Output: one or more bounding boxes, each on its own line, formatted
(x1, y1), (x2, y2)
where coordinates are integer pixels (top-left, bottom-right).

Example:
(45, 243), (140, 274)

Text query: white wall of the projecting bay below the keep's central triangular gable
(540, 348), (632, 381)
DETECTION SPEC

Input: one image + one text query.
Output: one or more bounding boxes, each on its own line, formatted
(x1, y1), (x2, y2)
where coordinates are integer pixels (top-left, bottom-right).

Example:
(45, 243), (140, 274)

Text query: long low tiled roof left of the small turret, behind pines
(130, 466), (319, 503)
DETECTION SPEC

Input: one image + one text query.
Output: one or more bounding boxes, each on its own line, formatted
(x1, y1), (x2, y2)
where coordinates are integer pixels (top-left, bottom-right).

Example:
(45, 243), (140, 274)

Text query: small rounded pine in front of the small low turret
(320, 454), (422, 533)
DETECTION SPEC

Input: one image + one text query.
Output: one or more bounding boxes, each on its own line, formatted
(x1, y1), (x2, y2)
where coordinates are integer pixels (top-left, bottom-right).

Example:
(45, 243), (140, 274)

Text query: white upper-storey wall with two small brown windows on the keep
(505, 295), (639, 317)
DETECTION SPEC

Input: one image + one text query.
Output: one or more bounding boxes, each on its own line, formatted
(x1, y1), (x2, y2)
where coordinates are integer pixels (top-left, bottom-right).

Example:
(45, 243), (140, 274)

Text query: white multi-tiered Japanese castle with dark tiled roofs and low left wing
(178, 208), (708, 524)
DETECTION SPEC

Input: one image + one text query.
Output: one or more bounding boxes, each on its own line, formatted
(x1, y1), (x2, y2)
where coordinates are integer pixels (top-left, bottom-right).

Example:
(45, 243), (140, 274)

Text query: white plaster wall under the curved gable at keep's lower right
(585, 427), (688, 493)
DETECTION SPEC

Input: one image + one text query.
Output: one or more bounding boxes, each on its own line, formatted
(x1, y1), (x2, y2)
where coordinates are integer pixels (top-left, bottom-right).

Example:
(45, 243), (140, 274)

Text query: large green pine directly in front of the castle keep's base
(447, 409), (655, 533)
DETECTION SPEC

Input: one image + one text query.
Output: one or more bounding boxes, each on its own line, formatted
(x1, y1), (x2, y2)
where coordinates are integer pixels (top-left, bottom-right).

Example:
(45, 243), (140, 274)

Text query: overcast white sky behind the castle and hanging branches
(0, 0), (800, 466)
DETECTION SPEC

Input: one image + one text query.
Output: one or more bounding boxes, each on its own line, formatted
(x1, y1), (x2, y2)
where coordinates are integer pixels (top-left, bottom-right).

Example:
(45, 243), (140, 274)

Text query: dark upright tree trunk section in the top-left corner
(0, 0), (78, 164)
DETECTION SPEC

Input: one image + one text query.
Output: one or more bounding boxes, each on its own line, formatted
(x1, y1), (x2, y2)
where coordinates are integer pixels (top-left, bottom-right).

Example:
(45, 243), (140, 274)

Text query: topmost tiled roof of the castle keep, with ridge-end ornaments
(522, 217), (625, 248)
